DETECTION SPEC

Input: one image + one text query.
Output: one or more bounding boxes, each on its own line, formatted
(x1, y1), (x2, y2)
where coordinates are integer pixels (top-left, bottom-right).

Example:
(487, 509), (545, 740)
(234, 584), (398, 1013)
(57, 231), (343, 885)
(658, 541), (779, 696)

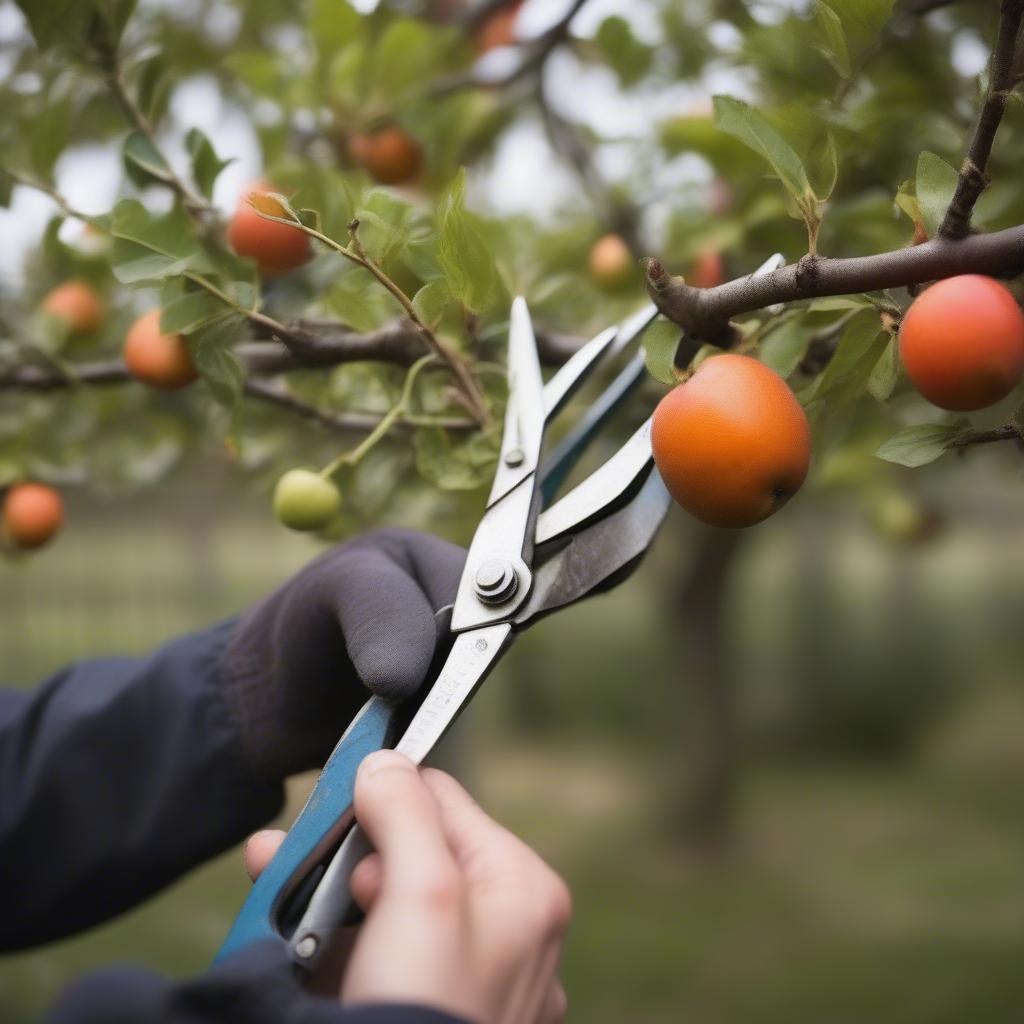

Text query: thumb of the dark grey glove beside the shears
(331, 547), (437, 700)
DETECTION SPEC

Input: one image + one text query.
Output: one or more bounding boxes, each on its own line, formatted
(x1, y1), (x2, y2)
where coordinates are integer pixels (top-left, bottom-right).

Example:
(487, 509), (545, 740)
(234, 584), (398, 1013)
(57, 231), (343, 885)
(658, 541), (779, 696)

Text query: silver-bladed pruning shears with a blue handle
(215, 257), (780, 972)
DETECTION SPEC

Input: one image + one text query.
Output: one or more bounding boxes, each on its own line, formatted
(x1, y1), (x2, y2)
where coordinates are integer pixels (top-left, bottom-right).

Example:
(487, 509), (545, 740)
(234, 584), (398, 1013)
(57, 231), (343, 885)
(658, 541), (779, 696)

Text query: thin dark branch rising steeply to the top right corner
(939, 0), (1024, 239)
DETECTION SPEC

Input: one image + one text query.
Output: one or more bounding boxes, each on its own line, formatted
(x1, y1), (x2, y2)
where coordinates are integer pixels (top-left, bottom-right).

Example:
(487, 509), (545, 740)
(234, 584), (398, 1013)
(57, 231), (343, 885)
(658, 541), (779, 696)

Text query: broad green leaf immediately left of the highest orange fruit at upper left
(111, 199), (213, 285)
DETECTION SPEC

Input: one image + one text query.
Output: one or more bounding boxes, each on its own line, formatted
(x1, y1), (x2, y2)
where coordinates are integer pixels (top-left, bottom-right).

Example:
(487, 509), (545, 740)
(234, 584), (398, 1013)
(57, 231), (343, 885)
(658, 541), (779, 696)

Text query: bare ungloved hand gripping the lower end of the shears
(246, 751), (570, 1024)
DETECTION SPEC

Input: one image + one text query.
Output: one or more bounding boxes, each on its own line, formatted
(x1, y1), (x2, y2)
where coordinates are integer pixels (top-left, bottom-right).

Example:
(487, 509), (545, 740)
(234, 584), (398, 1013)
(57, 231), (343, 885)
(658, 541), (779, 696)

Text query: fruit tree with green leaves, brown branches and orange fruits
(0, 0), (1024, 551)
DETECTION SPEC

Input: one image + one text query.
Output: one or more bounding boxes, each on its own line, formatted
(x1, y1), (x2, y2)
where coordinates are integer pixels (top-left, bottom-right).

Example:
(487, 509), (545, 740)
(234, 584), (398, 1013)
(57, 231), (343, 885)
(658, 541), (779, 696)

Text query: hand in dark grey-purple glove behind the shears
(223, 529), (466, 779)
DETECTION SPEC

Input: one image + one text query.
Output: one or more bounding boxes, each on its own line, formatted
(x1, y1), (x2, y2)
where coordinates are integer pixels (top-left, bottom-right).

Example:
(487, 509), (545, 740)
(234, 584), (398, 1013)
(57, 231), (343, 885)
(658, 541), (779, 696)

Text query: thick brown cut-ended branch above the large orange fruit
(645, 224), (1024, 342)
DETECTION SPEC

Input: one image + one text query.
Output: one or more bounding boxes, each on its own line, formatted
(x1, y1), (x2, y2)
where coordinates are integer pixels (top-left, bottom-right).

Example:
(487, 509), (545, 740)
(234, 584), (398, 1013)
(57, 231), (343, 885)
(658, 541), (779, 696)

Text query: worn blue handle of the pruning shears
(214, 697), (398, 964)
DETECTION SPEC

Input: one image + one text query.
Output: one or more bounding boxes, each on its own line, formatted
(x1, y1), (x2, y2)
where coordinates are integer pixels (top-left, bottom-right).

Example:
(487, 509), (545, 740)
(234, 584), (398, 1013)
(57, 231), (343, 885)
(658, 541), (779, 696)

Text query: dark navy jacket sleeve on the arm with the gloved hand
(0, 623), (284, 950)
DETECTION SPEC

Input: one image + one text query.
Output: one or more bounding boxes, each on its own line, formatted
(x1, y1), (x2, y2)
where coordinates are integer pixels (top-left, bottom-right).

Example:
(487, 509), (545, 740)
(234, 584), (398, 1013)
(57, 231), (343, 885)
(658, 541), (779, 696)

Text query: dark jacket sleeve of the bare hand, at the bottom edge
(47, 942), (467, 1024)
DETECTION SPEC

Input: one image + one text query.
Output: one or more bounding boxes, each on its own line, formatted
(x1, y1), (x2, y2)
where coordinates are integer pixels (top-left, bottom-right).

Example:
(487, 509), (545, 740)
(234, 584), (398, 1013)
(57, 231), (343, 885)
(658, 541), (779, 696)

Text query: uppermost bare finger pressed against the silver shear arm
(355, 751), (458, 901)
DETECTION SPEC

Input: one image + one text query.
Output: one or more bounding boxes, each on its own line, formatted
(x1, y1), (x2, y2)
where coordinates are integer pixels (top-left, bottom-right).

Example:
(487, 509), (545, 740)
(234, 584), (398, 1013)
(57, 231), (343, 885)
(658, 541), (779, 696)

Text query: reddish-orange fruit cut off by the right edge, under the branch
(899, 273), (1024, 413)
